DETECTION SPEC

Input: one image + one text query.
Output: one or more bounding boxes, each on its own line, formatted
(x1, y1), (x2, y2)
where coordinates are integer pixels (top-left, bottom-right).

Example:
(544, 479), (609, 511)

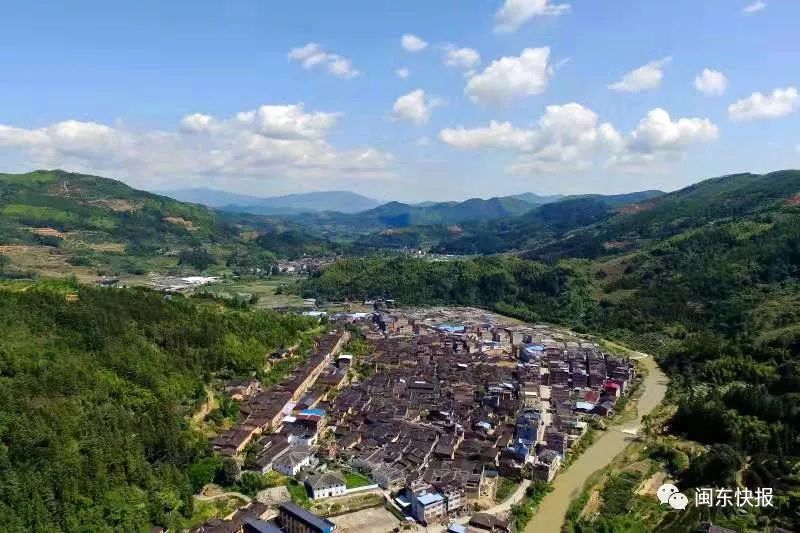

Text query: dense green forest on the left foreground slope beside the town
(0, 282), (310, 532)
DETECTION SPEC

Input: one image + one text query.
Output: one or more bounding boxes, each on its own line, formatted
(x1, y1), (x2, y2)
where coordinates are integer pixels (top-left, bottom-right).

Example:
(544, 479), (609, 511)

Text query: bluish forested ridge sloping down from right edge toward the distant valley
(434, 170), (800, 260)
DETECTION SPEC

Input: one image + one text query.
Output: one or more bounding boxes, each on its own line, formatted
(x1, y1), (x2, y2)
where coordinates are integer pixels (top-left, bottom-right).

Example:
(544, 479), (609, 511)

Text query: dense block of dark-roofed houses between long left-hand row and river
(304, 313), (634, 523)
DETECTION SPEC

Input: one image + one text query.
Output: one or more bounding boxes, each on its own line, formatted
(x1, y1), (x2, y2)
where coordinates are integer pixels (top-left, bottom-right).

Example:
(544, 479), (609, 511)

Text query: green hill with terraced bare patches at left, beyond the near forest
(0, 170), (340, 274)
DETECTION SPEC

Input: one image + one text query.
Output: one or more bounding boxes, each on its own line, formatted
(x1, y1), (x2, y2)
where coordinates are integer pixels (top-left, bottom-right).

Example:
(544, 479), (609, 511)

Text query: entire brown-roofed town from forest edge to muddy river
(192, 302), (638, 533)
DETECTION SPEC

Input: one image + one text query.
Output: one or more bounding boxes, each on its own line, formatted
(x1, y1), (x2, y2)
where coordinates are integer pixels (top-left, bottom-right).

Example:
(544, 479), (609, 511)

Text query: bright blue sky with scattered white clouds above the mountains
(0, 0), (800, 200)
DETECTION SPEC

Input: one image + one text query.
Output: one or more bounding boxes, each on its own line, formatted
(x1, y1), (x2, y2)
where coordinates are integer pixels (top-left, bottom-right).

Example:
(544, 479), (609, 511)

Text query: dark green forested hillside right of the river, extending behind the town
(299, 172), (800, 527)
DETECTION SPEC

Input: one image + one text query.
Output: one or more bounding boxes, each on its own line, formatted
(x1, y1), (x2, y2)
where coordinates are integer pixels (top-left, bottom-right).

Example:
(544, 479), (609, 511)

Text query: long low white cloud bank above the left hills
(0, 104), (391, 187)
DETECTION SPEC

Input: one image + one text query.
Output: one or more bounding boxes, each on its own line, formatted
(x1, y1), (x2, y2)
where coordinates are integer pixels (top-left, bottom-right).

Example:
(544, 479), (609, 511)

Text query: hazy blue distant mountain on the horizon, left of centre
(163, 188), (381, 215)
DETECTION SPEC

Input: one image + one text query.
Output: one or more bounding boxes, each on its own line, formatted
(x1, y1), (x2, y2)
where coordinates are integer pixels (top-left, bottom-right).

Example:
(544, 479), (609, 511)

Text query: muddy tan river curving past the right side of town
(525, 356), (668, 533)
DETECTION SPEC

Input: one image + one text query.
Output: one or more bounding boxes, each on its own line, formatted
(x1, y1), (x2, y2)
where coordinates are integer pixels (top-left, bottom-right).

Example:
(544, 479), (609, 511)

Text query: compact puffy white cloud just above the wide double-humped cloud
(464, 47), (553, 104)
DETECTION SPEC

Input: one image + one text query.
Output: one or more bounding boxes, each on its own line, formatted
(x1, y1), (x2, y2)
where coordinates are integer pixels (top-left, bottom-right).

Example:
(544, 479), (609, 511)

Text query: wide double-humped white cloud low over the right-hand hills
(439, 103), (719, 174)
